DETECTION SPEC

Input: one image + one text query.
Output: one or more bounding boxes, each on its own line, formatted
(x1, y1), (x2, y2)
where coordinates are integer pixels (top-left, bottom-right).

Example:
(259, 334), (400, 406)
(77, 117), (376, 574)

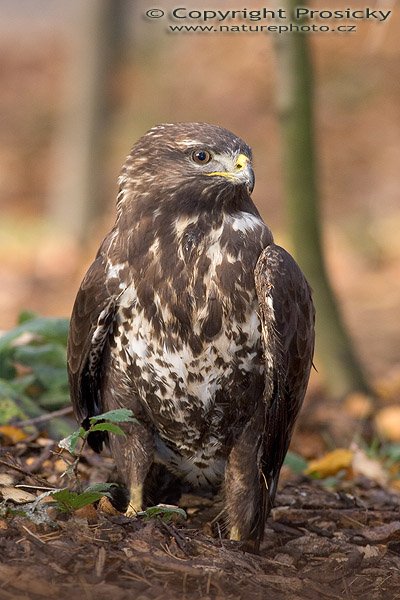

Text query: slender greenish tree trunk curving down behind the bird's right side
(276, 0), (370, 397)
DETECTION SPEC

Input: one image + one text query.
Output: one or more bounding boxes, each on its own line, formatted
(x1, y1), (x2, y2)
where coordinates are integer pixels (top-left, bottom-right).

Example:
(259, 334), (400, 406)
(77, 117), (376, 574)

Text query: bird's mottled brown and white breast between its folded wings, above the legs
(113, 216), (263, 462)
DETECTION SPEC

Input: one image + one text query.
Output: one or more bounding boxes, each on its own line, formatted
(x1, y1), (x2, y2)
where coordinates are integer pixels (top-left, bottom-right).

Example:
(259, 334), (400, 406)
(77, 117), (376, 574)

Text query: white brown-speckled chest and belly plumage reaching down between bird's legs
(112, 213), (264, 487)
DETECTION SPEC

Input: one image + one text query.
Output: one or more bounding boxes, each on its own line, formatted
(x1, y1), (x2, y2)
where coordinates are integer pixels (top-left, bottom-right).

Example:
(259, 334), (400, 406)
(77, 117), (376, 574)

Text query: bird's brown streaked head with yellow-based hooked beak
(120, 123), (254, 216)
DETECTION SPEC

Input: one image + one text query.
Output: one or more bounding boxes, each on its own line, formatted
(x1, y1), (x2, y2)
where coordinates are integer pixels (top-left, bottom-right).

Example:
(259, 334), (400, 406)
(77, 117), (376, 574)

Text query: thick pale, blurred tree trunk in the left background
(48, 0), (130, 242)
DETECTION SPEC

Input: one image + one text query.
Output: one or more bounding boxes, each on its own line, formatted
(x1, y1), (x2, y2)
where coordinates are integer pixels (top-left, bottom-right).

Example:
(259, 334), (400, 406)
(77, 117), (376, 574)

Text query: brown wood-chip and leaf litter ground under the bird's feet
(0, 440), (400, 600)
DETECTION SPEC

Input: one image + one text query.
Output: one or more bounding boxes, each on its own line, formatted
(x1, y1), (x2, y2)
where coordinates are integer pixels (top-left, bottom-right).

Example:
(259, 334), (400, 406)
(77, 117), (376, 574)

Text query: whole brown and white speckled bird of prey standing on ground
(68, 123), (314, 547)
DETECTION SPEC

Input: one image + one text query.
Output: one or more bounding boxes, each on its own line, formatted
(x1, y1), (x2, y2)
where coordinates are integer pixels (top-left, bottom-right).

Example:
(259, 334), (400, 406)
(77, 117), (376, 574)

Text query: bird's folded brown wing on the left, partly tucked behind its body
(68, 244), (123, 432)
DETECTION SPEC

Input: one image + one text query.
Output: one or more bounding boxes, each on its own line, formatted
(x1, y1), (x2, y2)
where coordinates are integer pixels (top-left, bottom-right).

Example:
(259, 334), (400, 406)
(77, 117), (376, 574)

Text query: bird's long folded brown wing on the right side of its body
(255, 244), (315, 512)
